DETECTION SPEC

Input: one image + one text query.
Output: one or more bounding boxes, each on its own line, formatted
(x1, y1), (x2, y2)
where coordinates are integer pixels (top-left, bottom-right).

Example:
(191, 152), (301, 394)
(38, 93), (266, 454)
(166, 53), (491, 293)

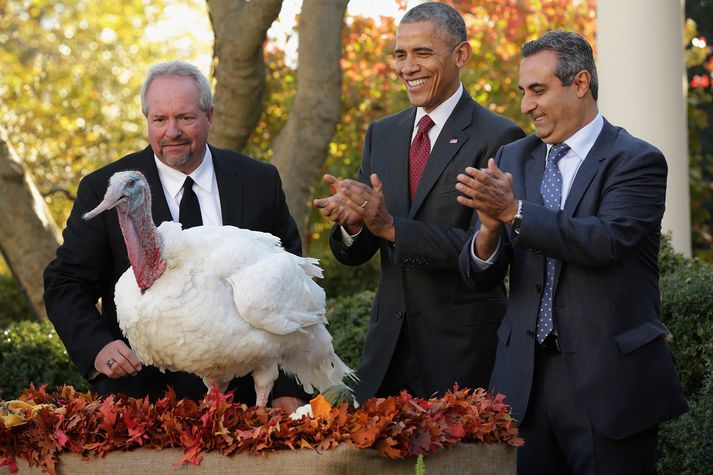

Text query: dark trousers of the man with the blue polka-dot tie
(517, 352), (658, 475)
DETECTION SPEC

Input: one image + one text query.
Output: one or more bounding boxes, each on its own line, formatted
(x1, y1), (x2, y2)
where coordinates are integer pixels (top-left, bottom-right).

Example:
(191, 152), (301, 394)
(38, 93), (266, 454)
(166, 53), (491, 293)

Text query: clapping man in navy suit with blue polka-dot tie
(457, 31), (687, 475)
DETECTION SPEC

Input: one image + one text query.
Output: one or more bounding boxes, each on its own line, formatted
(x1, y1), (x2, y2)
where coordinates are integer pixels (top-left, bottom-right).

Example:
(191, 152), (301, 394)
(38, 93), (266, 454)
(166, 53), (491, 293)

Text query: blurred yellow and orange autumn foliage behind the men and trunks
(0, 0), (713, 276)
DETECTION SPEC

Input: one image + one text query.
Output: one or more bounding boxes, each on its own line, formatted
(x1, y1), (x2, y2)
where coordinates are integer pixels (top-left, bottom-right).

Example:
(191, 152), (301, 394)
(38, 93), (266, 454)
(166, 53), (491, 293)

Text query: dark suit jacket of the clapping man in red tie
(330, 90), (524, 400)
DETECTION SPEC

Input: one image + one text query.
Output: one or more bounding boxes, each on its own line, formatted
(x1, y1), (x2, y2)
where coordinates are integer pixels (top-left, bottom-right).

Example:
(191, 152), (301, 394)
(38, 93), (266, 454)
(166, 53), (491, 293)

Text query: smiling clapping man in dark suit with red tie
(315, 3), (524, 406)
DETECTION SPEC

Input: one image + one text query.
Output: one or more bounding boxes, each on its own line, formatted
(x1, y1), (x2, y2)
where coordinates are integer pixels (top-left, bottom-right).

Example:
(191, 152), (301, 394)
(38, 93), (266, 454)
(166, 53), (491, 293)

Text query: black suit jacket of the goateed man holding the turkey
(45, 147), (307, 404)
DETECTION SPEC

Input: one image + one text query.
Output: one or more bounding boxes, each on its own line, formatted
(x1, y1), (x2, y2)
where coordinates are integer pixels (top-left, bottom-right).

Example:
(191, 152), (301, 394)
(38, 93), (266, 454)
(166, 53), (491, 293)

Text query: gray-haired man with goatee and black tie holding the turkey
(45, 61), (307, 411)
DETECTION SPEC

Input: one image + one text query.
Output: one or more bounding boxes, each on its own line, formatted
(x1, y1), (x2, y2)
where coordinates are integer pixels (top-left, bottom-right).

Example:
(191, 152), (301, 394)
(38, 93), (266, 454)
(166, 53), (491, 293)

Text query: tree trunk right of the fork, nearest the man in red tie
(272, 0), (348, 249)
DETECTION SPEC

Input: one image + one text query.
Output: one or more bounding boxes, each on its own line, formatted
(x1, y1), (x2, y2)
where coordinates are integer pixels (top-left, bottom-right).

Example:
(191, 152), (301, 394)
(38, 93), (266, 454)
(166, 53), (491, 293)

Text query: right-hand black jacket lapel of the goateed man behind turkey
(209, 145), (245, 227)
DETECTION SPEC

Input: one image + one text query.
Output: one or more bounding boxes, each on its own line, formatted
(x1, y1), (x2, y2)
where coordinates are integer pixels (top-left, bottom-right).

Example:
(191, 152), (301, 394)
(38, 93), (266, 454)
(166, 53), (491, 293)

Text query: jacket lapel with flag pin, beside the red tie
(406, 93), (475, 218)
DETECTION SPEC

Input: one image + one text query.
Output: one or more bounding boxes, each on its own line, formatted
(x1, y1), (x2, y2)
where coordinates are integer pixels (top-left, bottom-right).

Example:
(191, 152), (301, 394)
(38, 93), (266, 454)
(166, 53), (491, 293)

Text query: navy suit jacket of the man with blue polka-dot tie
(461, 120), (687, 439)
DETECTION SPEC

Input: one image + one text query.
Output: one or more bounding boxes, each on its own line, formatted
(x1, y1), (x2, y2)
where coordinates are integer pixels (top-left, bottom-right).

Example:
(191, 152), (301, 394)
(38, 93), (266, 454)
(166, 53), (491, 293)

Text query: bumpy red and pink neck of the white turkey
(119, 202), (166, 291)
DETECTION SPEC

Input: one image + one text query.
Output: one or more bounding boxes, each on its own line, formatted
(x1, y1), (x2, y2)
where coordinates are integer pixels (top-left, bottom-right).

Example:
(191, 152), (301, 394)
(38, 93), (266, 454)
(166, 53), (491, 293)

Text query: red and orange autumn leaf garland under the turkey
(0, 386), (522, 474)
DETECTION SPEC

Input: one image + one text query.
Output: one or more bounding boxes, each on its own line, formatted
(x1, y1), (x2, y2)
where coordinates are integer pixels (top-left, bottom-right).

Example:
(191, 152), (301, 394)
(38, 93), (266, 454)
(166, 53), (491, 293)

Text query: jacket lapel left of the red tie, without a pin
(384, 107), (416, 216)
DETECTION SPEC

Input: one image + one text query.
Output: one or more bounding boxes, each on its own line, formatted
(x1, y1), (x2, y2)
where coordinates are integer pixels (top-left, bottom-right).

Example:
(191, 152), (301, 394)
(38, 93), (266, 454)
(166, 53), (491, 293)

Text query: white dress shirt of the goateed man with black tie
(154, 146), (223, 226)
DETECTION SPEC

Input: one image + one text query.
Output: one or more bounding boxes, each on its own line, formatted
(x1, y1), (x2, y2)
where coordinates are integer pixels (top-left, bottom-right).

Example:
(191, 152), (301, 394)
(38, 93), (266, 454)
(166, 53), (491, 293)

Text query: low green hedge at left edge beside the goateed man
(0, 321), (88, 400)
